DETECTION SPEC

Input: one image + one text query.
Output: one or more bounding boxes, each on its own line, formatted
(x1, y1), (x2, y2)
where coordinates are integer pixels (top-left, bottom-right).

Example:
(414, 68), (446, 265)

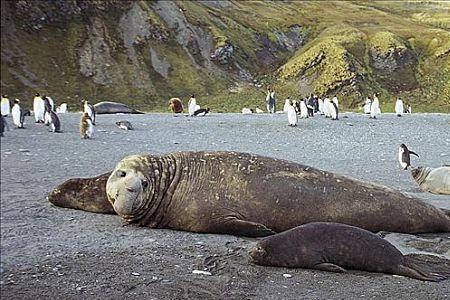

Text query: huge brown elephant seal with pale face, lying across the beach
(49, 152), (450, 236)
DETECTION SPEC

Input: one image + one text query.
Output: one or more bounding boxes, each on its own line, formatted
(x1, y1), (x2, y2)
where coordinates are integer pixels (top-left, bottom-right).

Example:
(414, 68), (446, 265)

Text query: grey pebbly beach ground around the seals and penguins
(0, 113), (450, 299)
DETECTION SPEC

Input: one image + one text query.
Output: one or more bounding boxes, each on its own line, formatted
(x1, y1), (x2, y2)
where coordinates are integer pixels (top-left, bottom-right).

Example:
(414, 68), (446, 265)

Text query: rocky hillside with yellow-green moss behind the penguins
(1, 0), (450, 111)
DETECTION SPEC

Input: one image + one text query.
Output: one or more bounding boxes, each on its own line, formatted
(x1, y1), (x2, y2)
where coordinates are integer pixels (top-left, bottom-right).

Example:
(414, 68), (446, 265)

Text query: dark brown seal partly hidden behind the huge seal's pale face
(47, 172), (115, 214)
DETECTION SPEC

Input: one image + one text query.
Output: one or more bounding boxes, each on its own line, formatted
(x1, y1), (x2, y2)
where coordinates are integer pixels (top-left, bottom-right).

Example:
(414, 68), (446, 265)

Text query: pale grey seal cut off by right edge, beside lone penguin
(411, 166), (450, 195)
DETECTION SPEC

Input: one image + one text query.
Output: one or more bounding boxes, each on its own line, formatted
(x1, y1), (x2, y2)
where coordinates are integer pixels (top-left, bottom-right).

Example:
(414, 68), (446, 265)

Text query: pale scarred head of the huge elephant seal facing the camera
(106, 155), (153, 222)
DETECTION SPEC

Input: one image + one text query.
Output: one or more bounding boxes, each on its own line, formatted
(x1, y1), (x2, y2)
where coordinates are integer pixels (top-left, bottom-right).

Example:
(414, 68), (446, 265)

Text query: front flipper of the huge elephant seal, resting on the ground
(218, 217), (276, 237)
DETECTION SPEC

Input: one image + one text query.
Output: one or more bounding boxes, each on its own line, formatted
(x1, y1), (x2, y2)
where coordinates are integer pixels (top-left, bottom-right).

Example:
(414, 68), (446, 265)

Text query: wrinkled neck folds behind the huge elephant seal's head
(122, 154), (181, 228)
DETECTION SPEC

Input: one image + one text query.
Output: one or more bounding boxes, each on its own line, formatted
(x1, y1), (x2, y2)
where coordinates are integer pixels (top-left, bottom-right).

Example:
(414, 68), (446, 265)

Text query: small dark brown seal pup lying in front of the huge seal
(249, 222), (446, 281)
